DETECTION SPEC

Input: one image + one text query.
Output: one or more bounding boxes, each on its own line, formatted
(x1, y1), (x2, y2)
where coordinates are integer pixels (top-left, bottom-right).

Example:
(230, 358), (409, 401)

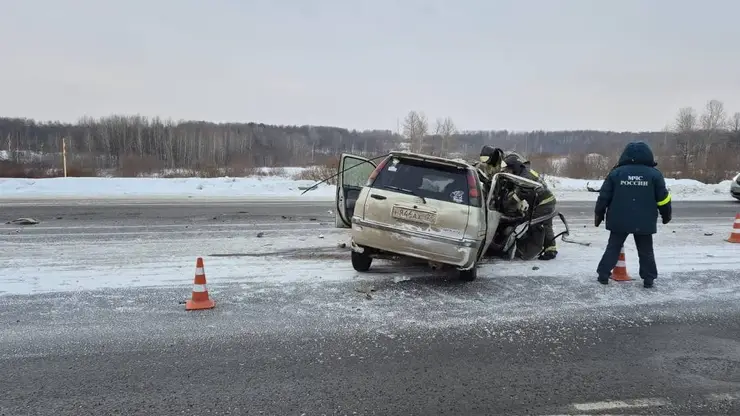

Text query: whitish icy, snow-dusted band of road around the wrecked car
(0, 203), (740, 325)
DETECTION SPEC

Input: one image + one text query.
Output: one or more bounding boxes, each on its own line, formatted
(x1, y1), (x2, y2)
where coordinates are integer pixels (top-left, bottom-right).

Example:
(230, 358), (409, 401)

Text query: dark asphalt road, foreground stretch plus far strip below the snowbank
(0, 201), (740, 416)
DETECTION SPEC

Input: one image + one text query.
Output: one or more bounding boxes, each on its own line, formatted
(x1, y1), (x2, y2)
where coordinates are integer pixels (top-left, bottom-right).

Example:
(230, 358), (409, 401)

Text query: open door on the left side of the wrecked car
(334, 153), (376, 228)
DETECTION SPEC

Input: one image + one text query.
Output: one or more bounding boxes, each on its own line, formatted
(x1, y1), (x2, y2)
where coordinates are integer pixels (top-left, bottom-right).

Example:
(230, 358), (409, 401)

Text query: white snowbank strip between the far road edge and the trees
(0, 168), (732, 201)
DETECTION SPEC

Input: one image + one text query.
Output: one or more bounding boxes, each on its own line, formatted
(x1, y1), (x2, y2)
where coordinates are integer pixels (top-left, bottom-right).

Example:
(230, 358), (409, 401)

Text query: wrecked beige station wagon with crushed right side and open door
(335, 151), (567, 281)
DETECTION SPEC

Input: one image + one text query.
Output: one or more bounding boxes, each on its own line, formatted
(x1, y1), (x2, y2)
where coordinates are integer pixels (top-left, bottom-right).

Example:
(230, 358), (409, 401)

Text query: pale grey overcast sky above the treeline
(0, 0), (740, 130)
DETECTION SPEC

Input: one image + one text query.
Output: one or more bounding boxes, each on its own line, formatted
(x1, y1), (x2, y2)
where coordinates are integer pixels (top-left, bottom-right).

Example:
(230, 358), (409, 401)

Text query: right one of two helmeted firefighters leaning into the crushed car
(502, 152), (558, 260)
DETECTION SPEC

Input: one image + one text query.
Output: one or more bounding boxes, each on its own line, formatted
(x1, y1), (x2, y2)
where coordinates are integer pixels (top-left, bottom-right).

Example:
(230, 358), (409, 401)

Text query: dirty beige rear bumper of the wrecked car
(352, 217), (481, 269)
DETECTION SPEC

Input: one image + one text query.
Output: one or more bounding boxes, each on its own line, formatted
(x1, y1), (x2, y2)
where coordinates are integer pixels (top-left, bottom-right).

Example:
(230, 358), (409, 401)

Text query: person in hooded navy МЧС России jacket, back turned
(594, 142), (672, 288)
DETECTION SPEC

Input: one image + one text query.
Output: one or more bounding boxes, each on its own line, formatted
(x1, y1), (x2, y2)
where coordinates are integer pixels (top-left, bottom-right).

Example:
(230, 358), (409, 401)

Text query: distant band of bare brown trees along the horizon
(0, 100), (740, 178)
